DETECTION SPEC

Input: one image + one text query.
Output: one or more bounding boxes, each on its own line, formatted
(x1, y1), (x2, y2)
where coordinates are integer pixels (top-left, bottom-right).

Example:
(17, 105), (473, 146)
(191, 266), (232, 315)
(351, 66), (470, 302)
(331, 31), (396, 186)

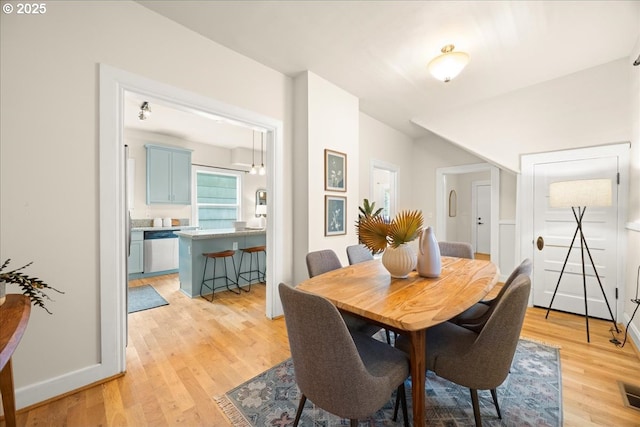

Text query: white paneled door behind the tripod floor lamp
(533, 156), (619, 320)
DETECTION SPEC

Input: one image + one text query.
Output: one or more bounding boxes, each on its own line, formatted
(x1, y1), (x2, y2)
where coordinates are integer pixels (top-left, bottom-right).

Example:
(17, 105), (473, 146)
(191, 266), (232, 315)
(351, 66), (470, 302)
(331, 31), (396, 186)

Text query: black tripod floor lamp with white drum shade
(545, 179), (620, 342)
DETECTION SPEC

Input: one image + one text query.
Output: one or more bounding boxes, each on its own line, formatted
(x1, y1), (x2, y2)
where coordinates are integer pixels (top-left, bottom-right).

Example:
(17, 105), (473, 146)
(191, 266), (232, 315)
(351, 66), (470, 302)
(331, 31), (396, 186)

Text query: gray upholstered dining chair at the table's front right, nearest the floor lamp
(396, 274), (531, 427)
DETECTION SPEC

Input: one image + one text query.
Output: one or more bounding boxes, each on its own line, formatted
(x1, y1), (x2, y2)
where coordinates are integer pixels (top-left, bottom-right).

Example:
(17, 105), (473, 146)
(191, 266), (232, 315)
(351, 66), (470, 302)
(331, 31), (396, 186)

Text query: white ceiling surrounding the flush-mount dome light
(132, 1), (640, 144)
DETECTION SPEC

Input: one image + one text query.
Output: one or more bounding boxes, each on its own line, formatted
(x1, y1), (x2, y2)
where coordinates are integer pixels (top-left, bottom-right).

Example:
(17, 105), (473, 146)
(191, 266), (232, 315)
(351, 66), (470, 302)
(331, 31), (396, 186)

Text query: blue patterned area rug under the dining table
(214, 339), (562, 427)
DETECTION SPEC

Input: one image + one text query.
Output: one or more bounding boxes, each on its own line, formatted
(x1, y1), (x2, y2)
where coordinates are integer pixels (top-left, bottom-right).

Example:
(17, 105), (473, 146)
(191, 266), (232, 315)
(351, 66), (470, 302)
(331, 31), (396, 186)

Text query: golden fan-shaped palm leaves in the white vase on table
(358, 210), (423, 254)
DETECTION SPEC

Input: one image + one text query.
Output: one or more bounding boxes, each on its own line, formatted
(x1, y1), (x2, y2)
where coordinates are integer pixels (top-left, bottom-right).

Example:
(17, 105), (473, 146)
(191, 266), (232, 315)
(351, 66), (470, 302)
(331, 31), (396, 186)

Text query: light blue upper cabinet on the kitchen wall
(145, 144), (191, 205)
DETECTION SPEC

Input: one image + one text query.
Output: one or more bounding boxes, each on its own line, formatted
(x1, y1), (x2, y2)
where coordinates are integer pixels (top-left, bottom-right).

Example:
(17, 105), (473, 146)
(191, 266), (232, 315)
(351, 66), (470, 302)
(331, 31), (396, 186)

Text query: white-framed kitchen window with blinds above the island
(194, 168), (241, 230)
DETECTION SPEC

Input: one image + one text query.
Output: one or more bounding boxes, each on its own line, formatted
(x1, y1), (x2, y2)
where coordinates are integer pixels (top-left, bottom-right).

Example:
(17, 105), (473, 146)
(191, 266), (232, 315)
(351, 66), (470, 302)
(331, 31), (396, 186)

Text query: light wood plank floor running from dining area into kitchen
(10, 275), (640, 427)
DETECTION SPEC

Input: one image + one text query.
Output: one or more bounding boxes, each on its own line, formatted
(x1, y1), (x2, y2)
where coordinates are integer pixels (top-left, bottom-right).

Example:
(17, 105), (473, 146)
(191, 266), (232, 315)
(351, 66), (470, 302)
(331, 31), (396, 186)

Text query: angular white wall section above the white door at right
(415, 58), (630, 172)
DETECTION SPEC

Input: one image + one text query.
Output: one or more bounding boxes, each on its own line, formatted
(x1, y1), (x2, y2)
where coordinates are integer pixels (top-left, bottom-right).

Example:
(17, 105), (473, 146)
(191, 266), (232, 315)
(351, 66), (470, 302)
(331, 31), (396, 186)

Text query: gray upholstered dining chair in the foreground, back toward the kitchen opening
(278, 283), (409, 427)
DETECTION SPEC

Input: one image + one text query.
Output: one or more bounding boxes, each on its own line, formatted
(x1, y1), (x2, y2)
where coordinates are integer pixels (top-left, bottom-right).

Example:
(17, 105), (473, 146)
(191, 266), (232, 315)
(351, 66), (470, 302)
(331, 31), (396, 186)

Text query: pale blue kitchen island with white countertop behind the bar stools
(175, 229), (267, 298)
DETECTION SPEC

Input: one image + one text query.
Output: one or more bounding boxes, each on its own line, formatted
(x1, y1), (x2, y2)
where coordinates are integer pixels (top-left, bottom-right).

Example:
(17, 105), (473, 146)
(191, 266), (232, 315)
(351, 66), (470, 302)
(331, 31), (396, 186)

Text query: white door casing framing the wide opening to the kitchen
(99, 64), (284, 377)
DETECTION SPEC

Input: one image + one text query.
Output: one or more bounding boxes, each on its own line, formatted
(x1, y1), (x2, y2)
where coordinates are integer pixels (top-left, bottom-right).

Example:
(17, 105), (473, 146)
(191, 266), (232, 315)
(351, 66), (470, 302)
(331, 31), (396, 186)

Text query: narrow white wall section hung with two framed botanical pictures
(294, 71), (360, 281)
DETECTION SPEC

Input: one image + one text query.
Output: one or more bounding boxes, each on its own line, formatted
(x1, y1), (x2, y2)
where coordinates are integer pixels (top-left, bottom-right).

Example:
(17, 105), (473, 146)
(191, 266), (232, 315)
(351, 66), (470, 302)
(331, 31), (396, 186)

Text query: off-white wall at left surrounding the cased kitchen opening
(0, 1), (292, 407)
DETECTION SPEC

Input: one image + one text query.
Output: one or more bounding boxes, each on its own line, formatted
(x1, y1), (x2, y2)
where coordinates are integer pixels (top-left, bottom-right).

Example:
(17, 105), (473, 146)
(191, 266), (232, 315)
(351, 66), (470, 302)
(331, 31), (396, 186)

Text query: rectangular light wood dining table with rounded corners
(298, 256), (499, 426)
